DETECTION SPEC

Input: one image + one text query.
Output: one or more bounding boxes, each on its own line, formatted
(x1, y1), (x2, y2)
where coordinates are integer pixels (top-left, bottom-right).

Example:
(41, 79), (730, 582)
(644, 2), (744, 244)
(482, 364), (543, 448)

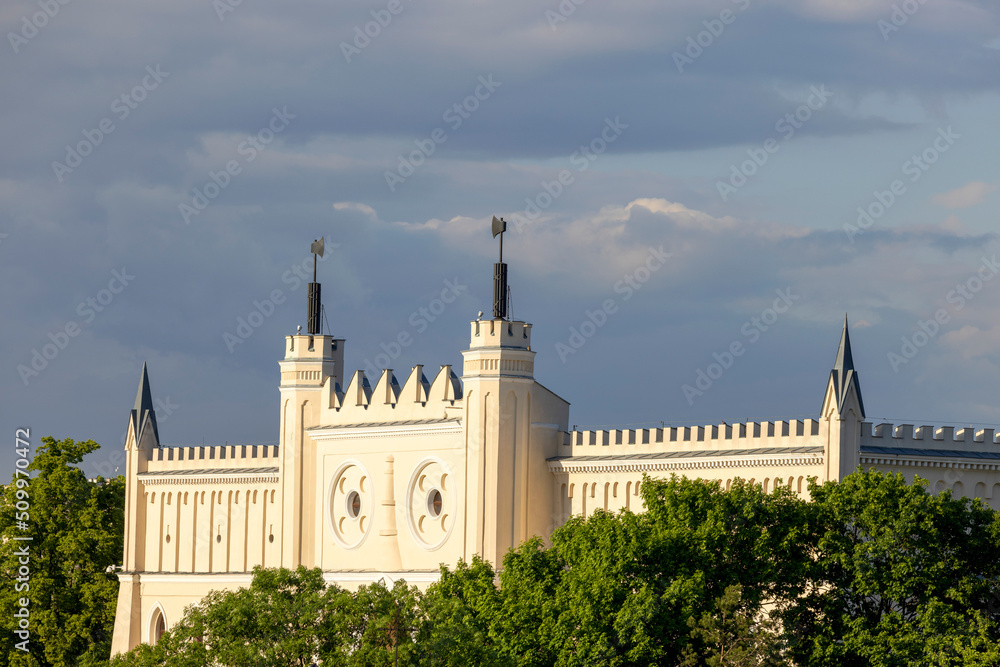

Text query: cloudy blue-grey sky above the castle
(0, 0), (1000, 474)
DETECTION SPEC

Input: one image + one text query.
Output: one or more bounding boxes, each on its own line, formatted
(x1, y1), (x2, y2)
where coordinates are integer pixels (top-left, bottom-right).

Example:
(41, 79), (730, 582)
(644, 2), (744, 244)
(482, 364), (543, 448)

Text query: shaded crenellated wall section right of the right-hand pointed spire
(860, 422), (1000, 510)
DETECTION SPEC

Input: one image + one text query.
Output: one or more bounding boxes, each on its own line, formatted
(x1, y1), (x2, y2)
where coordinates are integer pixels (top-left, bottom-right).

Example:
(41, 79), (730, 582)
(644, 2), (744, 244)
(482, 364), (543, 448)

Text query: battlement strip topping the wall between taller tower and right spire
(563, 419), (822, 455)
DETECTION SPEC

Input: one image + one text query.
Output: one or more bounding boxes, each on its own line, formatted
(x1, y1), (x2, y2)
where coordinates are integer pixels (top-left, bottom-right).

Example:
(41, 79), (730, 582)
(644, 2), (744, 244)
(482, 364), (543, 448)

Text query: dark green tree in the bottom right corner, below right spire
(786, 471), (1000, 667)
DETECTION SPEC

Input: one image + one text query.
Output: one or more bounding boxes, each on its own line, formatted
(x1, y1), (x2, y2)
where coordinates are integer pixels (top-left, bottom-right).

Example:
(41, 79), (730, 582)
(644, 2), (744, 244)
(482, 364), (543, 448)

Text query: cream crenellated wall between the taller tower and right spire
(549, 419), (828, 523)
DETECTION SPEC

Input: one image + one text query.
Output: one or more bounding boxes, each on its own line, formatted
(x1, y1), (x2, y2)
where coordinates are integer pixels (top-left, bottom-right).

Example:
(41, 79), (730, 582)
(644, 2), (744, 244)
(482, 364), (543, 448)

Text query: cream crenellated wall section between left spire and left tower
(137, 445), (281, 573)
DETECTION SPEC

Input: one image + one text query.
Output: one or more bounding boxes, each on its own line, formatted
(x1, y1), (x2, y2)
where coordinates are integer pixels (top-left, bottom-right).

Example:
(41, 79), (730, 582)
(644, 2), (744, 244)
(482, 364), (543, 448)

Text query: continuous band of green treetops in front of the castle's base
(72, 471), (1000, 667)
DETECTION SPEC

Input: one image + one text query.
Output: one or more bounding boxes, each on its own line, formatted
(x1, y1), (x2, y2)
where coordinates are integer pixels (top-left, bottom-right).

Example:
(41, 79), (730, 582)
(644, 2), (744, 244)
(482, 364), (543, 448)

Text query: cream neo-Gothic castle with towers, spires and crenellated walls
(112, 247), (1000, 653)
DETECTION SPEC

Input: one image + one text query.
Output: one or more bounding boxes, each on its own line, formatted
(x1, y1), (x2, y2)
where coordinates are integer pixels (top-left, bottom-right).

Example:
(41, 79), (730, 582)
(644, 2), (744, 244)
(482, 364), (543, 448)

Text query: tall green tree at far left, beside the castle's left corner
(0, 437), (125, 667)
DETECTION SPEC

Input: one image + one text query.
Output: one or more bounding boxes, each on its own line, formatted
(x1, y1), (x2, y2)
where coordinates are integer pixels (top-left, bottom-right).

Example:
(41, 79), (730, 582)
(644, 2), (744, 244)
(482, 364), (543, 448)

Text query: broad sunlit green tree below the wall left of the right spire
(491, 477), (815, 667)
